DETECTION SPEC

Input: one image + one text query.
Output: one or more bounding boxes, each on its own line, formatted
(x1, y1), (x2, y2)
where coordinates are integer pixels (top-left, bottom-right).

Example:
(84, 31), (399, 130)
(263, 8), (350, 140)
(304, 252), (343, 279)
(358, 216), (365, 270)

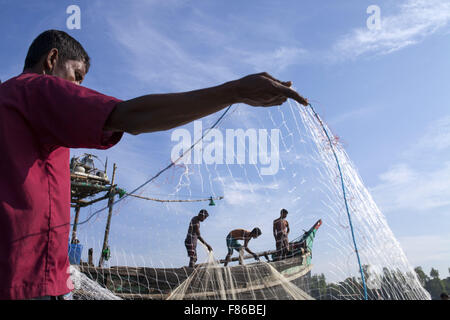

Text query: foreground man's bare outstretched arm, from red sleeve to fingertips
(104, 73), (308, 135)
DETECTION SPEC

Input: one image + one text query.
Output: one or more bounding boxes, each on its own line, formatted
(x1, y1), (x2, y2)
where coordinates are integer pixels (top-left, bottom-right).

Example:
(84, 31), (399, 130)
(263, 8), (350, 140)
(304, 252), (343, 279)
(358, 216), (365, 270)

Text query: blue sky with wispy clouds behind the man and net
(0, 0), (450, 276)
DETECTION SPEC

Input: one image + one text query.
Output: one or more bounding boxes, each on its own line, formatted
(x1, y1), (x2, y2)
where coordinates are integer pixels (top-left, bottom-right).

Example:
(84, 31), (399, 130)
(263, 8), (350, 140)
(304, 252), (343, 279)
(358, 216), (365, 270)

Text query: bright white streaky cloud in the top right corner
(334, 0), (450, 58)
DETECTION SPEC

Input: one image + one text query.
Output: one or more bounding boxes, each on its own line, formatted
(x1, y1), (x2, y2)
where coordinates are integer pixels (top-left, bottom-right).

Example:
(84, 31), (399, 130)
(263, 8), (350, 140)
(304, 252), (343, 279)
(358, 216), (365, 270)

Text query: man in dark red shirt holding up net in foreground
(0, 30), (307, 299)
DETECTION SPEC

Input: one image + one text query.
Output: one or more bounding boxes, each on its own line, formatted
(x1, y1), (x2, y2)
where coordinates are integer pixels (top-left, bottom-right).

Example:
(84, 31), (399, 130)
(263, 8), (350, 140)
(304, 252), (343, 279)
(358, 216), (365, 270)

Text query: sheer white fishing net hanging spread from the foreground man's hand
(68, 101), (430, 300)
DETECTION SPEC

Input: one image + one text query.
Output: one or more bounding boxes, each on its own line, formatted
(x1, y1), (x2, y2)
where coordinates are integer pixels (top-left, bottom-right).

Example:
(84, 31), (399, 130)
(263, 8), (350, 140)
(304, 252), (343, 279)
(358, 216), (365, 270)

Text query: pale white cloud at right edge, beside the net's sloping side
(371, 117), (450, 212)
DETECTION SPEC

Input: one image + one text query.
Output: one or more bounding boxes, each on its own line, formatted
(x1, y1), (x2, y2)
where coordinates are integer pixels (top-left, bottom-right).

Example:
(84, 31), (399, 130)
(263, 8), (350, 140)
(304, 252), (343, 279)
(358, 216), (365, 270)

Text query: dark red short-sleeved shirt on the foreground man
(0, 73), (122, 299)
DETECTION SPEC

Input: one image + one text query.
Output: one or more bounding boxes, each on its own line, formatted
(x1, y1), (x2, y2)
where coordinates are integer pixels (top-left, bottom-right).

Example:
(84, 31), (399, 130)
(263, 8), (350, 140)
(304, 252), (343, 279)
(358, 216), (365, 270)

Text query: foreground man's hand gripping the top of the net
(234, 72), (308, 107)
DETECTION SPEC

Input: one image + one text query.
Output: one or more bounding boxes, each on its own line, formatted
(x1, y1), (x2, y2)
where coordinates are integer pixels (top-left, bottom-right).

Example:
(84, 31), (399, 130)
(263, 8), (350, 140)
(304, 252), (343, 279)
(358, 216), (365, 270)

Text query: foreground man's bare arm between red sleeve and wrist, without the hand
(105, 82), (238, 134)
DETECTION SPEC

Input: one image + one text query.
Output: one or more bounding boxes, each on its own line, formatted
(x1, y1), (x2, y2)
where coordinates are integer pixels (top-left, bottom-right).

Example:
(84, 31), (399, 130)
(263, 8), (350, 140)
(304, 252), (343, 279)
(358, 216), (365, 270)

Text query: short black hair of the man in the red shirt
(23, 30), (90, 73)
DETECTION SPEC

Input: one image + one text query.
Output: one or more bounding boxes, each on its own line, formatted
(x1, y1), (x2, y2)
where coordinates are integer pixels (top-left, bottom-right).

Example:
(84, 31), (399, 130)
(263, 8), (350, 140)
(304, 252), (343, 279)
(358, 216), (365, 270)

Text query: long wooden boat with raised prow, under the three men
(74, 220), (322, 300)
